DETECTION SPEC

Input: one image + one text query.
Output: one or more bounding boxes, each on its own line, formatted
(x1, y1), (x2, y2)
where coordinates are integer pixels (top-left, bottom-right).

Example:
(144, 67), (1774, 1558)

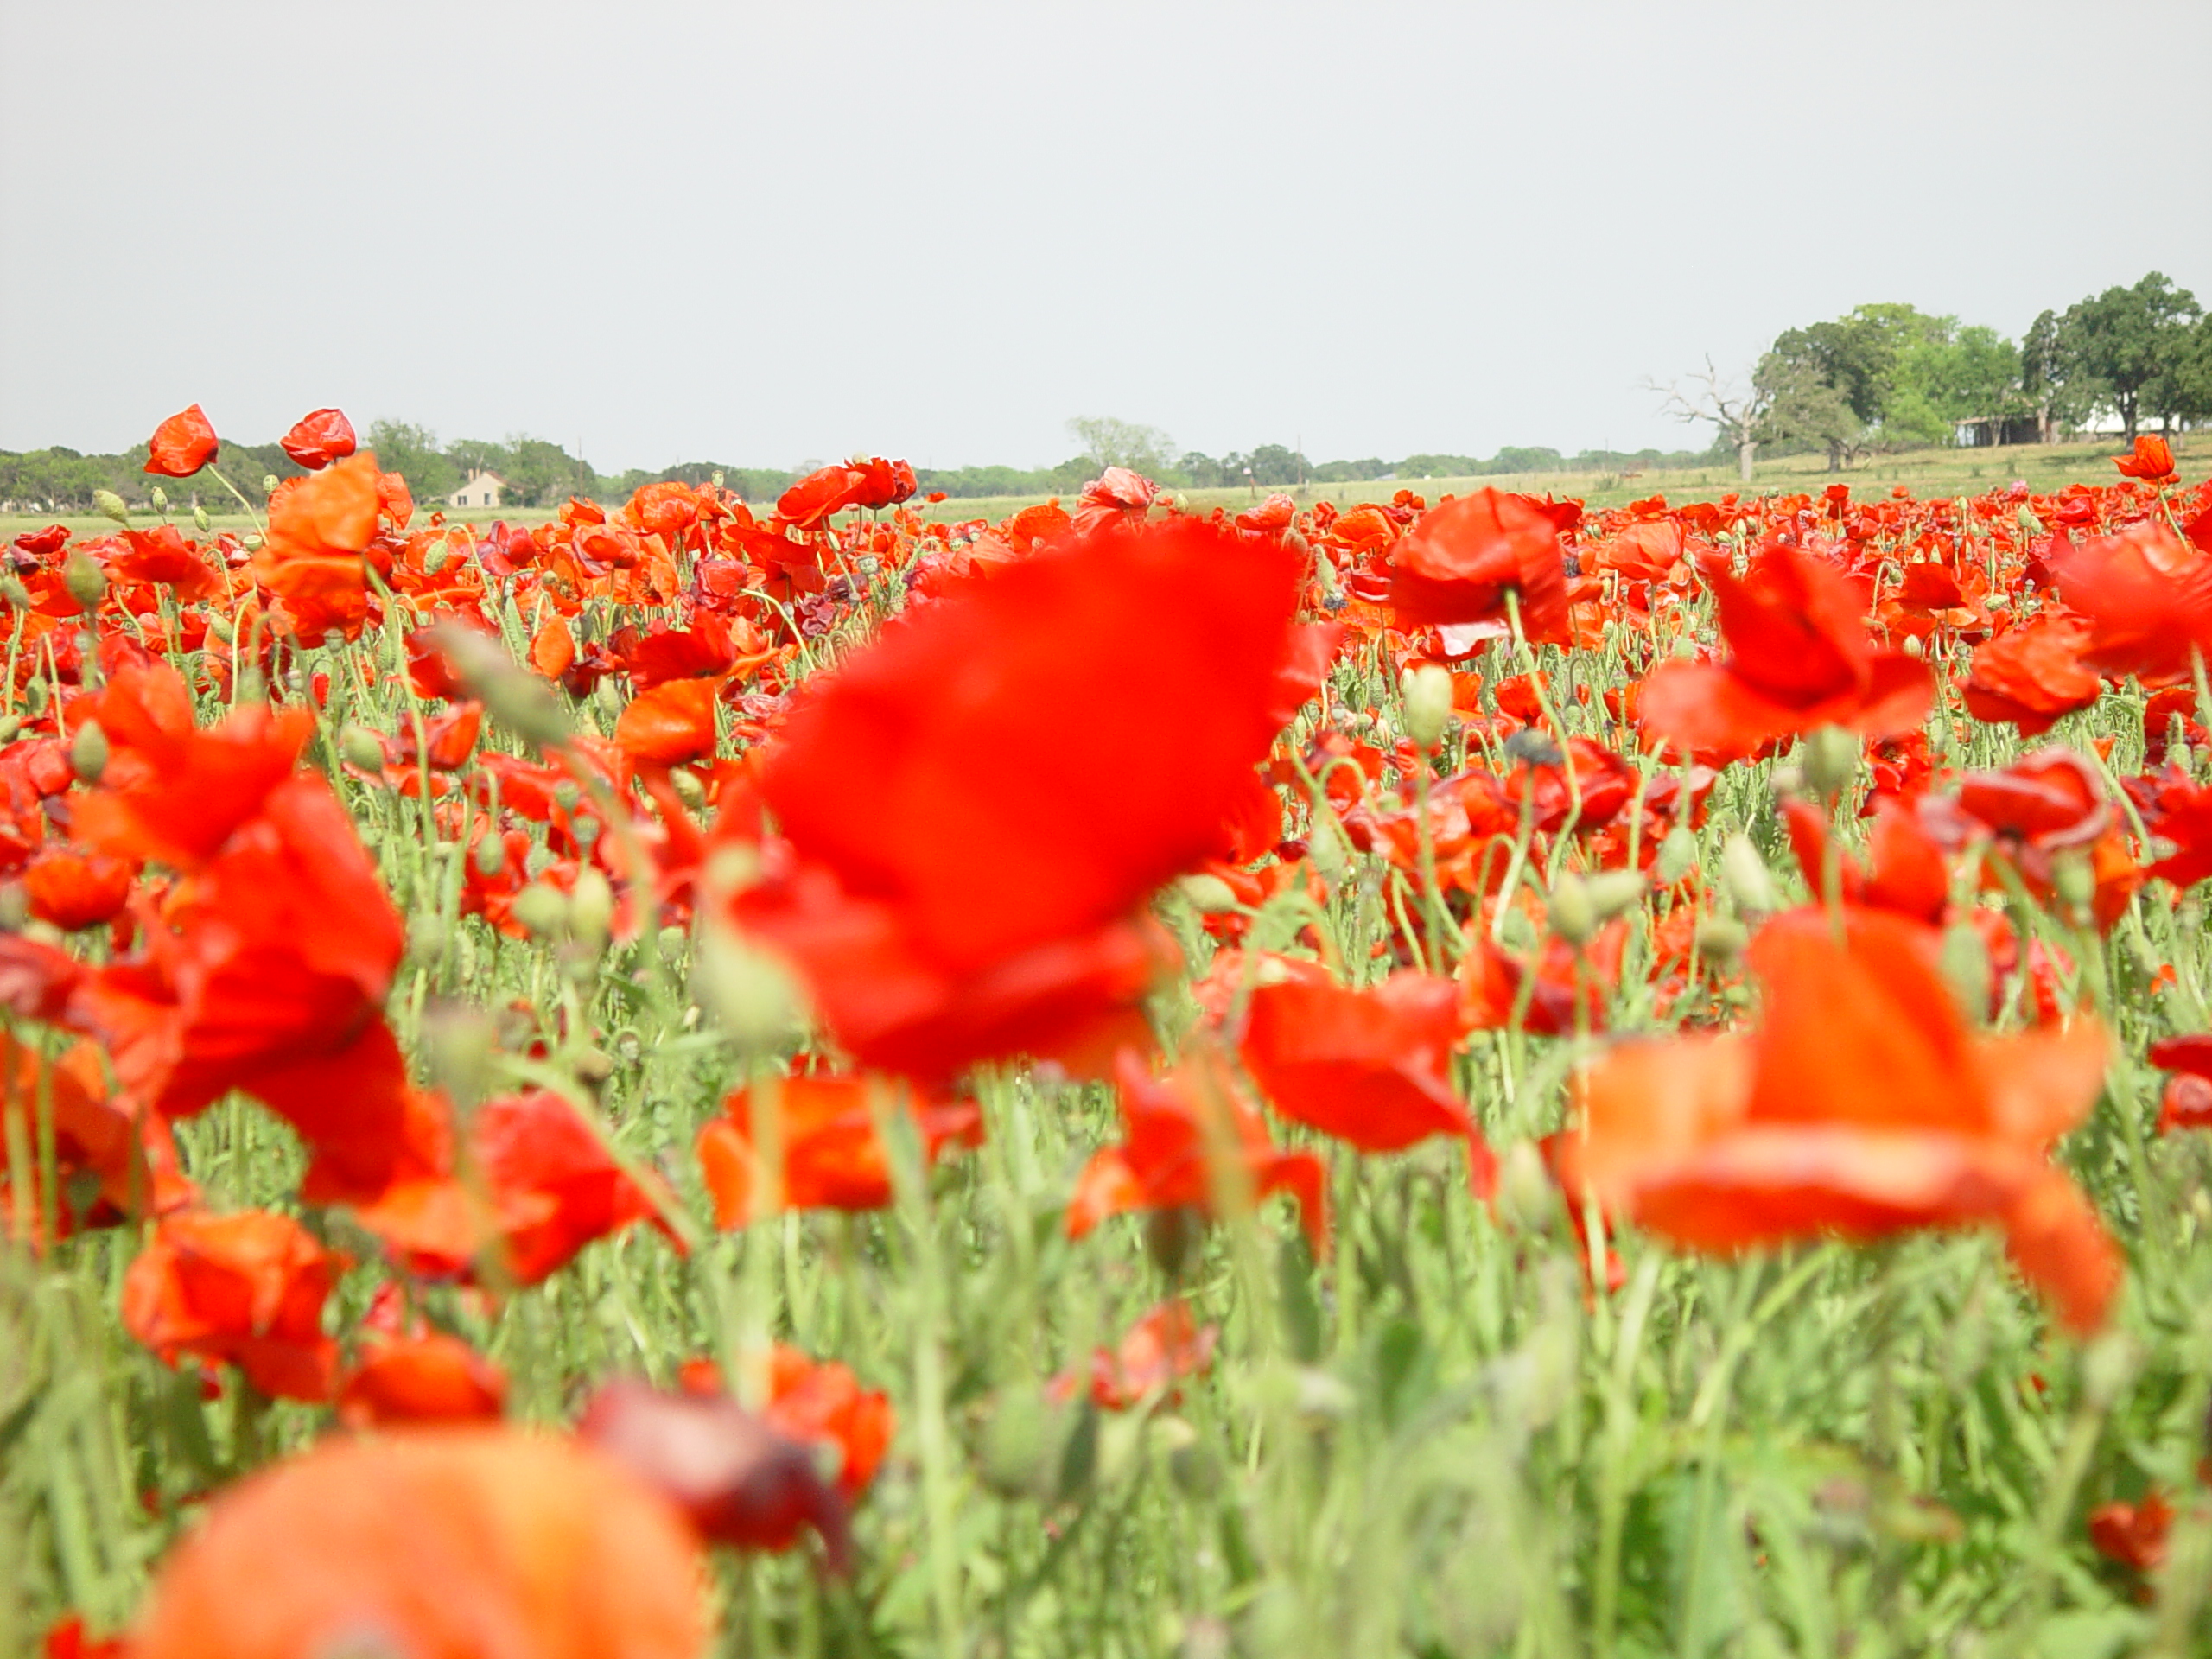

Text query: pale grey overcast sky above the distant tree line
(0, 0), (2212, 471)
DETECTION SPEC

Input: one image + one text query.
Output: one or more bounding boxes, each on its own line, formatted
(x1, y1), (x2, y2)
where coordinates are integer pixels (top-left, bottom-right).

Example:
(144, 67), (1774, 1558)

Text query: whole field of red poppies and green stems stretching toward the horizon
(0, 407), (2212, 1659)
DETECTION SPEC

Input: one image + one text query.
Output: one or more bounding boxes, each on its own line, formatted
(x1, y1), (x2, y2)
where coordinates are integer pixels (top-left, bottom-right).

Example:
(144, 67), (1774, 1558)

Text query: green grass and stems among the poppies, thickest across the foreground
(0, 477), (2212, 1659)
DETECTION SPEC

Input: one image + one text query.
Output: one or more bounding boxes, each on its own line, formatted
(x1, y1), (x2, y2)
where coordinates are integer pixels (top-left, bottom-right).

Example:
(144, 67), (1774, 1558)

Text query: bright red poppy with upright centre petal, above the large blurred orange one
(1637, 546), (1936, 759)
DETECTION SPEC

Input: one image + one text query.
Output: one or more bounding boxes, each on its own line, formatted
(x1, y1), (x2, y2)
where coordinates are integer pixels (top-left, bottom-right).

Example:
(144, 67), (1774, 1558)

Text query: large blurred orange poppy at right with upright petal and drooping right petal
(1557, 909), (2121, 1332)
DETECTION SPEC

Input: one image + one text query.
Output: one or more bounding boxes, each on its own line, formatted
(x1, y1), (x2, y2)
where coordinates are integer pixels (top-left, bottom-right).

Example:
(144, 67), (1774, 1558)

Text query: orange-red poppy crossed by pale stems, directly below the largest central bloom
(699, 1077), (982, 1228)
